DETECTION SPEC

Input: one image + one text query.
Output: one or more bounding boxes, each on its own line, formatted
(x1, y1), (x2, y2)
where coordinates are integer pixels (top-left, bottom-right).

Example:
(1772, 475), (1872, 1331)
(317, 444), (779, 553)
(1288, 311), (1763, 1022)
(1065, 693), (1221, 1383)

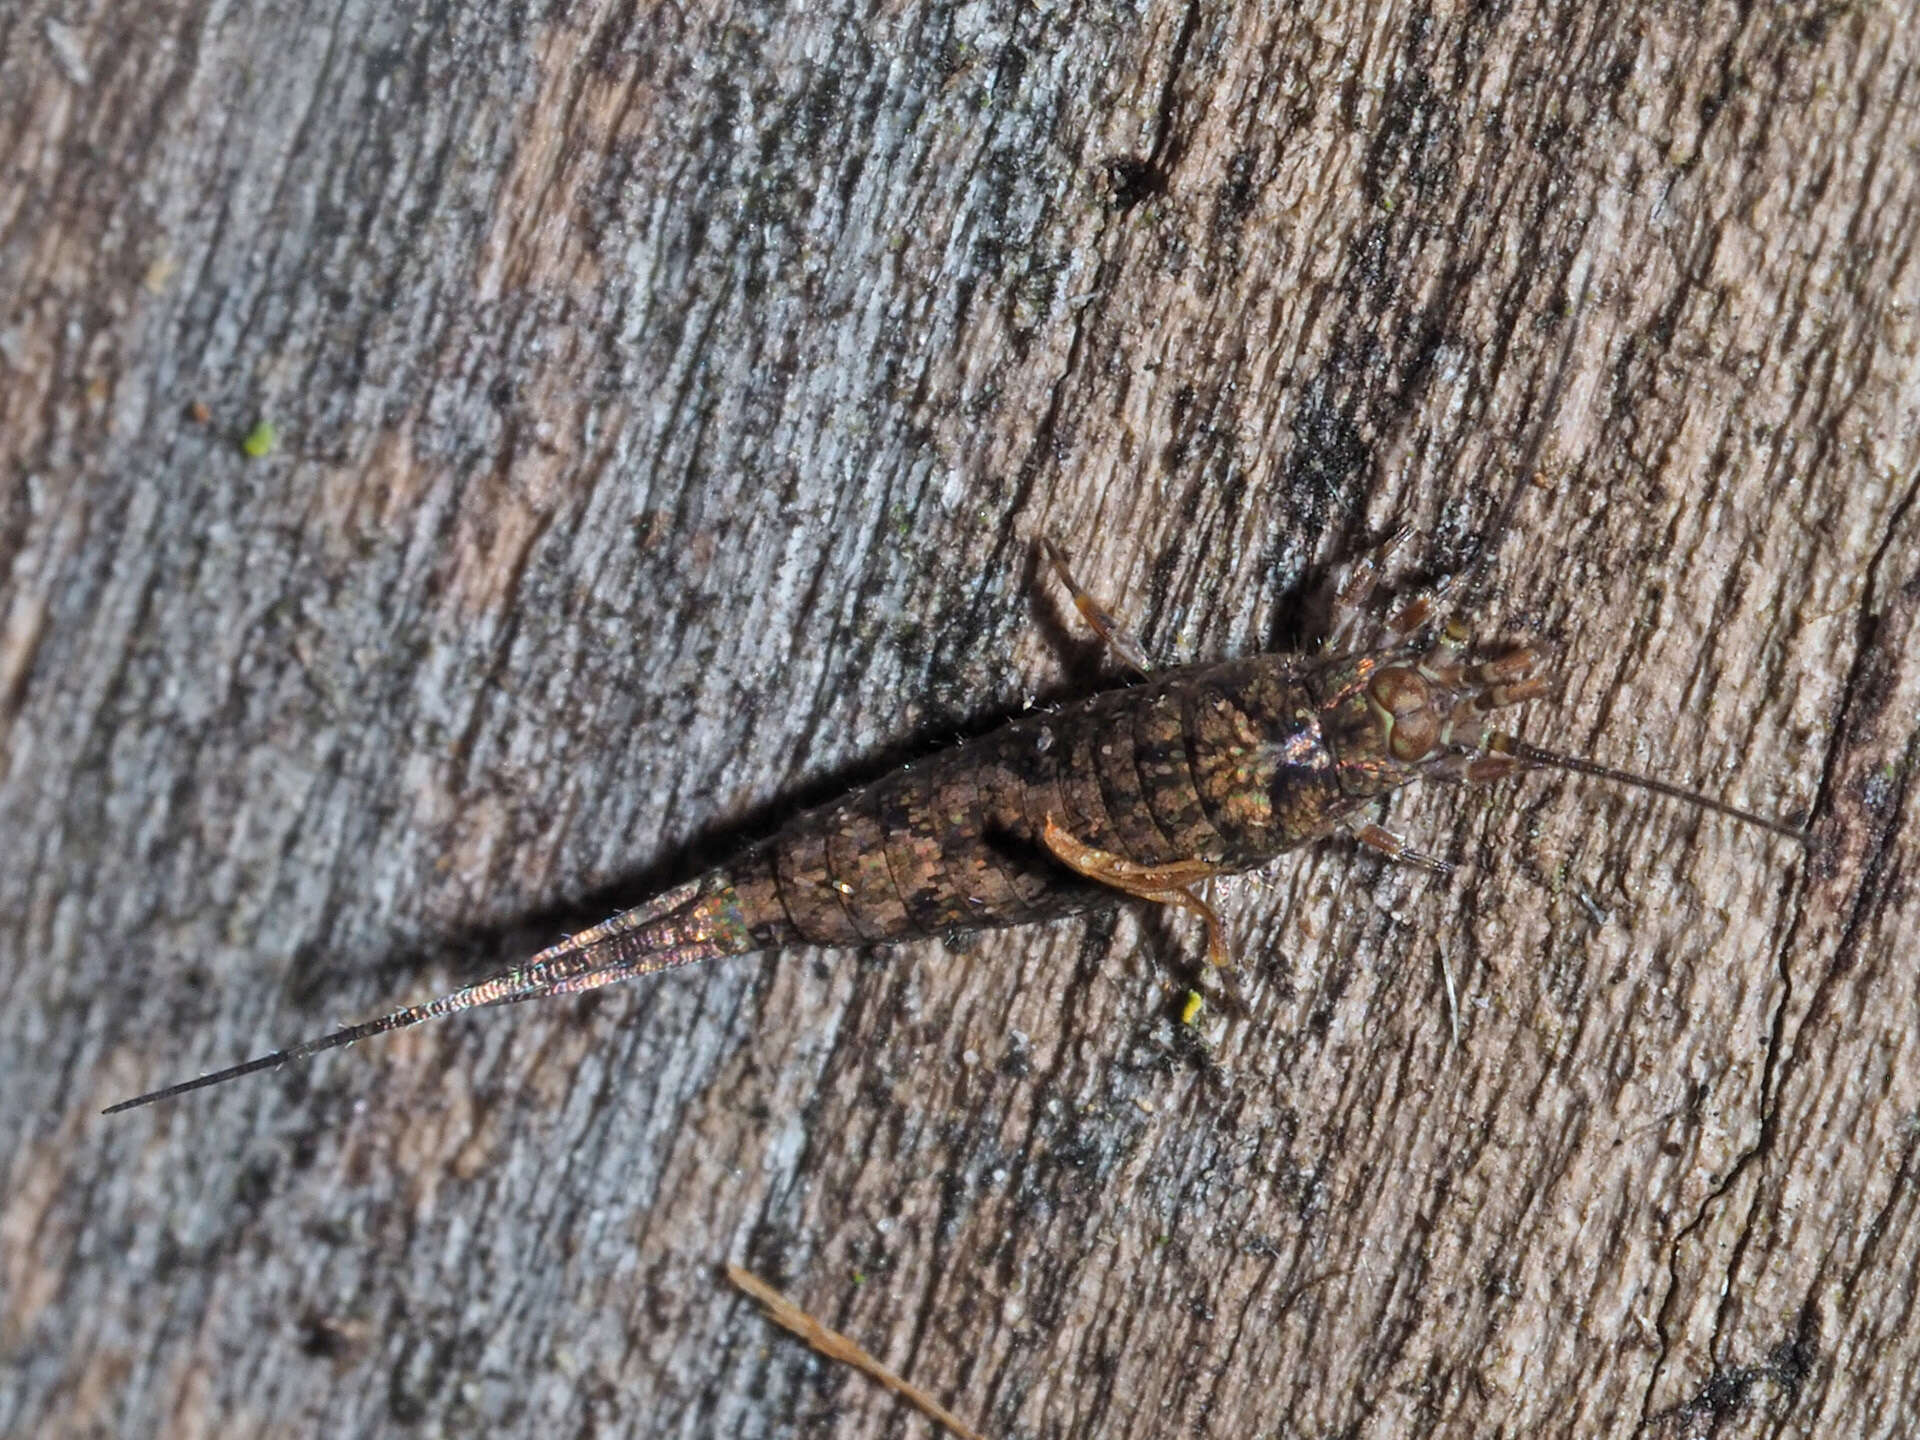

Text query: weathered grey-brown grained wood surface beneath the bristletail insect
(0, 0), (1920, 1436)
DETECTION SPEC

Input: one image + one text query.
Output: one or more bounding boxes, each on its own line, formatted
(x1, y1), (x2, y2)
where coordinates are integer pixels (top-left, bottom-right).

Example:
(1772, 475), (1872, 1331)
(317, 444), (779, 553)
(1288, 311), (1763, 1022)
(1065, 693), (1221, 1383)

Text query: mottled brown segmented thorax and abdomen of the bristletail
(724, 657), (1338, 945)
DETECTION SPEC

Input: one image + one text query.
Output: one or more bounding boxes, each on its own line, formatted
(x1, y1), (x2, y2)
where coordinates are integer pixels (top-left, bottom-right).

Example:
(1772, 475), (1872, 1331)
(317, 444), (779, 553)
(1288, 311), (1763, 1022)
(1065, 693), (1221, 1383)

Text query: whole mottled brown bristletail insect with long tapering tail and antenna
(113, 553), (1799, 1110)
